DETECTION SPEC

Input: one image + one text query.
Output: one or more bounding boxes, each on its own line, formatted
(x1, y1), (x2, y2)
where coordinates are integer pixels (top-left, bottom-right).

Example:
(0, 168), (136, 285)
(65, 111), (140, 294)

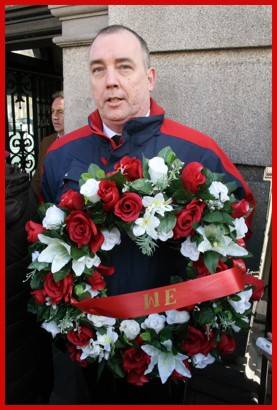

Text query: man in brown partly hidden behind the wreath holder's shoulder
(32, 91), (64, 197)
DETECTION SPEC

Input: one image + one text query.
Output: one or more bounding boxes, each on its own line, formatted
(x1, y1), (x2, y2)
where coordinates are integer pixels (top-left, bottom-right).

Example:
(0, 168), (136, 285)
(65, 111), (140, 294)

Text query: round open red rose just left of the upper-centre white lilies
(114, 192), (142, 222)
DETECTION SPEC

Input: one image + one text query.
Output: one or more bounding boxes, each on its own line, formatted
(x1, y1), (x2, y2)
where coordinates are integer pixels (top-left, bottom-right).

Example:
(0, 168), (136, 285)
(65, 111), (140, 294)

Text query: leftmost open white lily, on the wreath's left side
(37, 234), (71, 273)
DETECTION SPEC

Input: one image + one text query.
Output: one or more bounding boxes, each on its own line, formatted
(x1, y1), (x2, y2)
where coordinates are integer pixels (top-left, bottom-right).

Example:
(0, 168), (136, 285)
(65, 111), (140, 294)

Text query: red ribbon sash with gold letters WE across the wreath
(71, 267), (244, 319)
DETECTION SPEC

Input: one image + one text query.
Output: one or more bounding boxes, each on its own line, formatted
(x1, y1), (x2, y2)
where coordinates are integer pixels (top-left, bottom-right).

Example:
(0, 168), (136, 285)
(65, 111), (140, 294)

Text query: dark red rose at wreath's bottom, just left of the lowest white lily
(123, 347), (150, 386)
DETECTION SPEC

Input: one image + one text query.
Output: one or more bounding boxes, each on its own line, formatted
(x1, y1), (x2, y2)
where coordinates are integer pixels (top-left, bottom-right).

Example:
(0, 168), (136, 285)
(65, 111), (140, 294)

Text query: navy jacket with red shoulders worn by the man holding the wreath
(42, 99), (254, 295)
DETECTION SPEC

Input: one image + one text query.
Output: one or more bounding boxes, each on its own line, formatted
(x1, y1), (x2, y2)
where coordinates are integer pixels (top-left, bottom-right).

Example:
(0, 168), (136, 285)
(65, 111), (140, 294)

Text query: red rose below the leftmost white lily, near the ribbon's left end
(43, 272), (73, 304)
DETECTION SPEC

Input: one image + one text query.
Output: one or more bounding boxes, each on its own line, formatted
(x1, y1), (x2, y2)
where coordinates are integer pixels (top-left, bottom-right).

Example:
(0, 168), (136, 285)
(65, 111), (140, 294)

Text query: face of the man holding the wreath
(90, 30), (155, 132)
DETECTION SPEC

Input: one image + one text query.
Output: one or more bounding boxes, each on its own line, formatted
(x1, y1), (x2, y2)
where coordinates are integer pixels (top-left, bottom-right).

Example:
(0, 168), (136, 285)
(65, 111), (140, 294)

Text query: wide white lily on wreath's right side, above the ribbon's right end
(196, 225), (248, 256)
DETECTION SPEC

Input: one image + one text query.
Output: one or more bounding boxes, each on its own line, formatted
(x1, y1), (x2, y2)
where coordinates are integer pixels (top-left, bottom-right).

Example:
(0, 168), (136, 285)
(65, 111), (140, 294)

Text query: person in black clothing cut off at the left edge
(5, 162), (53, 405)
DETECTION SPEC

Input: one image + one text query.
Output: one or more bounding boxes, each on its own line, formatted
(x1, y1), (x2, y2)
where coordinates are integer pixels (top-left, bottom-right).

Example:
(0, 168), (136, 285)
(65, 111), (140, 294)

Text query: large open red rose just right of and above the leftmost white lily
(65, 211), (97, 248)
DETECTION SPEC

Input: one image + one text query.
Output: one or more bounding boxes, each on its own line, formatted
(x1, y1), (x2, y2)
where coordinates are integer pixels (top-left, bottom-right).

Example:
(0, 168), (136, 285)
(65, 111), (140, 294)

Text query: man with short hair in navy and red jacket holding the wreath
(42, 25), (253, 404)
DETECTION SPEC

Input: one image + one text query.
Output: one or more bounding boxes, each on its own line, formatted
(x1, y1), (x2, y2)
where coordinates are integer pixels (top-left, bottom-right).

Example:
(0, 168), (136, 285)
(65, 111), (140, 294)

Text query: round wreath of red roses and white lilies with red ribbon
(26, 147), (263, 386)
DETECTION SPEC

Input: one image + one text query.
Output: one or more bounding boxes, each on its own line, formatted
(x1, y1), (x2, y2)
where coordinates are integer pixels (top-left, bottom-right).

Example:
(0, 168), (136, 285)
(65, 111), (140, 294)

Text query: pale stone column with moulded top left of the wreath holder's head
(48, 5), (108, 133)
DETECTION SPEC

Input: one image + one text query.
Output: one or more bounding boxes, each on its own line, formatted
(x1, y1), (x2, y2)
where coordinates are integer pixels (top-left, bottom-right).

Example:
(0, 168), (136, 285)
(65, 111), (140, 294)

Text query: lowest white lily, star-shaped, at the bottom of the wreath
(141, 340), (191, 384)
